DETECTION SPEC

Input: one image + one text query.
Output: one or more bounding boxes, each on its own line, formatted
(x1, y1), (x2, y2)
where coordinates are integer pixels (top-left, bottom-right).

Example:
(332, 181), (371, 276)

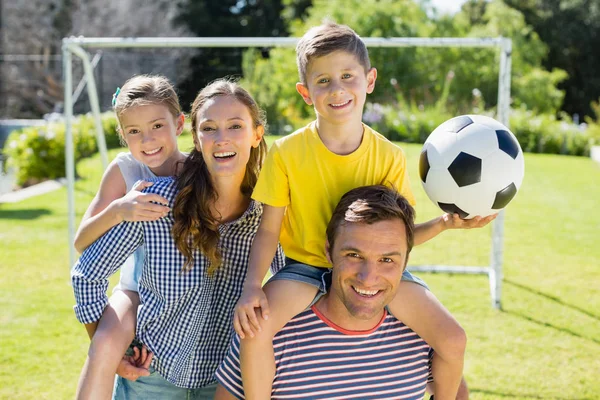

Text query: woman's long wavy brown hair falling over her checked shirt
(171, 79), (267, 275)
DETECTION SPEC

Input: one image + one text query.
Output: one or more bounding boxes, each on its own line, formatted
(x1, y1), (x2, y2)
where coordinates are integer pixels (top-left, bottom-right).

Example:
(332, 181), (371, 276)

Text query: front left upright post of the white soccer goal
(62, 40), (75, 266)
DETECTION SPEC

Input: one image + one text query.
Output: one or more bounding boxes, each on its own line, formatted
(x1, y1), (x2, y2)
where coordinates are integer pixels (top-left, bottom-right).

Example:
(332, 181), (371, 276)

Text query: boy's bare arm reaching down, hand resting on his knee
(233, 205), (285, 339)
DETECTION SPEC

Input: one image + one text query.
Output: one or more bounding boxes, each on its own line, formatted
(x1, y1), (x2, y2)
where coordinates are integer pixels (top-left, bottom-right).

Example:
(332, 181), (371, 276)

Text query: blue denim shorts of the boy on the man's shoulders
(267, 257), (429, 294)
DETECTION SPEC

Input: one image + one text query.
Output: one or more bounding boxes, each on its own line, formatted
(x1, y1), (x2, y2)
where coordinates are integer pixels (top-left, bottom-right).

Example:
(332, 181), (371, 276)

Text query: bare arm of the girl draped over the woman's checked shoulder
(74, 163), (168, 253)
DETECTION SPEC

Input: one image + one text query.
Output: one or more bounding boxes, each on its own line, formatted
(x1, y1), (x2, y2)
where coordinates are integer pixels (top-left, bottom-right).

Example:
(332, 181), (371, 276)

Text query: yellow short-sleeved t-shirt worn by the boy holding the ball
(252, 122), (415, 267)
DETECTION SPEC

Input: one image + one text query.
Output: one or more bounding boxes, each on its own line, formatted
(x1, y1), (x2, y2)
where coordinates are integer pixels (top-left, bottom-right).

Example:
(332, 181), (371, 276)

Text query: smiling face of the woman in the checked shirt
(194, 96), (264, 181)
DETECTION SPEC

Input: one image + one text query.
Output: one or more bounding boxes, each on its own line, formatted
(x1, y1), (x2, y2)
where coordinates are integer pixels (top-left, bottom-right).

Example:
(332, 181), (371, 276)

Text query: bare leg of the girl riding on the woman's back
(77, 290), (140, 400)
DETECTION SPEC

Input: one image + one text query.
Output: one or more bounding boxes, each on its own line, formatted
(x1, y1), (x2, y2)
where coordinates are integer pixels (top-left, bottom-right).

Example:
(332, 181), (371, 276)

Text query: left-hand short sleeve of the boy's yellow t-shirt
(252, 142), (290, 207)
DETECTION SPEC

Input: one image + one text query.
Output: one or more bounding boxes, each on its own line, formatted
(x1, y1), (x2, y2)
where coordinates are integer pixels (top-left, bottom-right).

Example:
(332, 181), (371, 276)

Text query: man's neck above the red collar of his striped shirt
(314, 293), (385, 332)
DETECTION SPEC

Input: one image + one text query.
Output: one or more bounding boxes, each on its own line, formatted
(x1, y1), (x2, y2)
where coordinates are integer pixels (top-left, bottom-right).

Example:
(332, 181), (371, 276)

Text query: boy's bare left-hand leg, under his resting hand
(240, 280), (317, 400)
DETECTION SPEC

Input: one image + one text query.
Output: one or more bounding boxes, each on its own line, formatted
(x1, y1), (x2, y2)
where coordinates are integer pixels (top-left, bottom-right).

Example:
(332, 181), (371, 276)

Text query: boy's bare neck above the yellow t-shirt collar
(316, 118), (364, 156)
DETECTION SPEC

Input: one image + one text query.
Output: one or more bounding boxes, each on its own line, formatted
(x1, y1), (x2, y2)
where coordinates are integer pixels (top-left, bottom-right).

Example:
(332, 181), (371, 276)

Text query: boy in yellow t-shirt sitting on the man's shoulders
(234, 23), (494, 400)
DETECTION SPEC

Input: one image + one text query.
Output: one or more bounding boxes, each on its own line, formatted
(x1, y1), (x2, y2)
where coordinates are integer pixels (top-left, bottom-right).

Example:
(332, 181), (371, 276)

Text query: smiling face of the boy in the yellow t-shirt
(296, 50), (377, 125)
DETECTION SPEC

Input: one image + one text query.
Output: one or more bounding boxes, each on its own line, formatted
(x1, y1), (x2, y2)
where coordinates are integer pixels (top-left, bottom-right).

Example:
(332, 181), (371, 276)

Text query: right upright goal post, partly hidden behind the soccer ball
(489, 38), (512, 310)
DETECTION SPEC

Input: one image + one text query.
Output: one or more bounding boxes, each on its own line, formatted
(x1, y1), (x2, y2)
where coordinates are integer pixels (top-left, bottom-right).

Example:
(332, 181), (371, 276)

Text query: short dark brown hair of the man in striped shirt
(327, 185), (415, 257)
